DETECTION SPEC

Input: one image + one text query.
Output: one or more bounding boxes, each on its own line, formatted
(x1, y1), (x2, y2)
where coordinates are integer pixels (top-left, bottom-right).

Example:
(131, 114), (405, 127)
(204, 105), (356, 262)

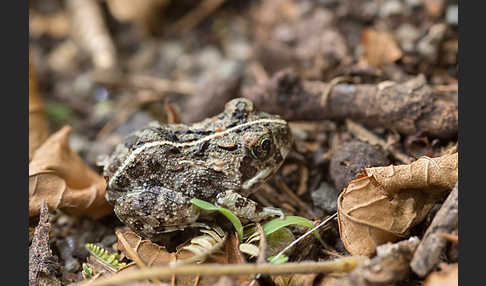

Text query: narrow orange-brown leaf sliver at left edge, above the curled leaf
(29, 51), (49, 161)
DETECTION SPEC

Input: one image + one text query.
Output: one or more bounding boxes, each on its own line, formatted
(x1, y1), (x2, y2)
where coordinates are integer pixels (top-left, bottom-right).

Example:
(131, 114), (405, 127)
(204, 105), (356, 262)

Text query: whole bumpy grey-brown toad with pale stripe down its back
(104, 98), (292, 239)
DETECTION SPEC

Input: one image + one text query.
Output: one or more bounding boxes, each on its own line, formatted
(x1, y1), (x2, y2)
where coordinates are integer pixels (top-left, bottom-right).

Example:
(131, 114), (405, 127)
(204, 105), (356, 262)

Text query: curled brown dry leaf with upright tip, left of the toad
(29, 126), (113, 218)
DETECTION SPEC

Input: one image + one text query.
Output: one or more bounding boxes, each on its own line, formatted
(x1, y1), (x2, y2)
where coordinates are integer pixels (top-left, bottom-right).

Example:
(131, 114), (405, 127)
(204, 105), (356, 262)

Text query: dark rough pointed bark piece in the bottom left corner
(29, 201), (60, 286)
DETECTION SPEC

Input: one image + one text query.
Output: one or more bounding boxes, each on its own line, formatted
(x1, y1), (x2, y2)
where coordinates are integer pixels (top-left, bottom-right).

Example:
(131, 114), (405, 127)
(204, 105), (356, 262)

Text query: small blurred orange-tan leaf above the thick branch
(362, 29), (403, 68)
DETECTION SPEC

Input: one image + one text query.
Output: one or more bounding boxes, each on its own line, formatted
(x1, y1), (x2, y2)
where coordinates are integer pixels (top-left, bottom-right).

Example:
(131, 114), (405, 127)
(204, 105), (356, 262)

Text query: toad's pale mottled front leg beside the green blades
(216, 191), (284, 222)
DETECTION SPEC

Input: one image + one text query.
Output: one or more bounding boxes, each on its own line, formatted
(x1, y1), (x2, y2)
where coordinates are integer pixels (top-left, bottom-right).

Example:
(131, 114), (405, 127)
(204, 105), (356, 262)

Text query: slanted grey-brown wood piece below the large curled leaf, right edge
(410, 184), (459, 277)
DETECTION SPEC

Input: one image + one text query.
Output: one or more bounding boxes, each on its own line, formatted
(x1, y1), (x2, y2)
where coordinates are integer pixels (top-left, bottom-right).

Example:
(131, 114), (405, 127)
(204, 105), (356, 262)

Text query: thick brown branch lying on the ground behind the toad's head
(243, 69), (458, 138)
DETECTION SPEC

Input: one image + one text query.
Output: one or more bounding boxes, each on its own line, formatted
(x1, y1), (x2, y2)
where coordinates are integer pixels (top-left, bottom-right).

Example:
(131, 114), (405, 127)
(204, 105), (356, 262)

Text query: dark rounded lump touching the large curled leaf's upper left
(329, 140), (390, 192)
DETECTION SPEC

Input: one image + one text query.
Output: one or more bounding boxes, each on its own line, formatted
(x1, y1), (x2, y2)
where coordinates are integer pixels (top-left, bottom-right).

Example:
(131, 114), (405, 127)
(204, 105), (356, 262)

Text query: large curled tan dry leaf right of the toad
(338, 153), (458, 256)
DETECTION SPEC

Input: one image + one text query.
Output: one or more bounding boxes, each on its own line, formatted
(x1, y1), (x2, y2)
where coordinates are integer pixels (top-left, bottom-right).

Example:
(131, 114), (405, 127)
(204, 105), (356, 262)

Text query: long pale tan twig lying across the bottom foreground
(71, 256), (367, 286)
